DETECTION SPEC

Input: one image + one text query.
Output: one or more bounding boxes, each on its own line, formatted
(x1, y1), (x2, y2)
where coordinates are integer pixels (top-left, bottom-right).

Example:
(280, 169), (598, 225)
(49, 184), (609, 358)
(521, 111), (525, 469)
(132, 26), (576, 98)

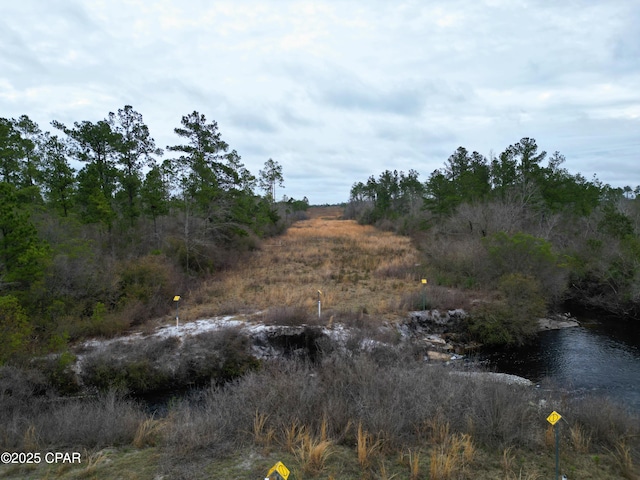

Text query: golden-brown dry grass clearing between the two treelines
(181, 206), (420, 320)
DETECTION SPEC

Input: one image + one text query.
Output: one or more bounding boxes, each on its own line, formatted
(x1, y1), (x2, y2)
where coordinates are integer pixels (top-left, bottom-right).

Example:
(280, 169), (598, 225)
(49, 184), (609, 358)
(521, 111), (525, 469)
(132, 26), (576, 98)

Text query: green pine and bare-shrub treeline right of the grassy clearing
(346, 138), (640, 341)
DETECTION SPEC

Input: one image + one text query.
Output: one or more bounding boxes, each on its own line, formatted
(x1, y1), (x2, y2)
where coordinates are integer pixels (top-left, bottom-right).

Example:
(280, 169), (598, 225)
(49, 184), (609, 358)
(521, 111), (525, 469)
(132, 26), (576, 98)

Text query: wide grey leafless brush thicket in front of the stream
(168, 348), (542, 458)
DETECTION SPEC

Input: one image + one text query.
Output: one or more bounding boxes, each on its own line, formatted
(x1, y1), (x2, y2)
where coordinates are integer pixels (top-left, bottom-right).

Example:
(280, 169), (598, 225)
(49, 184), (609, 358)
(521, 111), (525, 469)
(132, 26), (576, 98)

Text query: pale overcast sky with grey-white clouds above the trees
(0, 0), (640, 204)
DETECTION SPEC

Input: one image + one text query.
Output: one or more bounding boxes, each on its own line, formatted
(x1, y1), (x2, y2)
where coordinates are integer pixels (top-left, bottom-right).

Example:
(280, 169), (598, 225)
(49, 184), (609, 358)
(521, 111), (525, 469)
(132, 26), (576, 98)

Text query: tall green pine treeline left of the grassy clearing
(0, 105), (308, 363)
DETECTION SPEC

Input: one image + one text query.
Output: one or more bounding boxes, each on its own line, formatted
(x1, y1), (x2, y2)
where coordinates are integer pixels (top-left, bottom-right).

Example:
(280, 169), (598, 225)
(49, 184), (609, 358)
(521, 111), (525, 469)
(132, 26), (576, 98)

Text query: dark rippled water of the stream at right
(488, 321), (640, 412)
